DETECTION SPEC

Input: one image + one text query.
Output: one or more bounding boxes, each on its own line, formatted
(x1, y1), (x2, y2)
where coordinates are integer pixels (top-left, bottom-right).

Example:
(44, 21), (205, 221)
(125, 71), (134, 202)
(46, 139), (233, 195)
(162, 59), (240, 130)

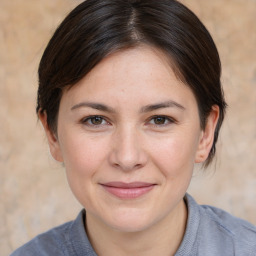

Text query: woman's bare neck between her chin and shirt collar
(86, 200), (187, 256)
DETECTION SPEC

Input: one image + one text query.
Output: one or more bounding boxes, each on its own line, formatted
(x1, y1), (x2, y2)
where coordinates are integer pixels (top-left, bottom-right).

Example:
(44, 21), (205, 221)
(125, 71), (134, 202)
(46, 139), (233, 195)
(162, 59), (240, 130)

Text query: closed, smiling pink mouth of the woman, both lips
(100, 182), (156, 199)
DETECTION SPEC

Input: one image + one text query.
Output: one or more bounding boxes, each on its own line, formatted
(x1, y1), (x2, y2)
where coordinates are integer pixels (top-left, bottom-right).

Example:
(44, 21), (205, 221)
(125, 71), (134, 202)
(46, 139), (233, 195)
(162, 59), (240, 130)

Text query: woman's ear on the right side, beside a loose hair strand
(195, 105), (219, 163)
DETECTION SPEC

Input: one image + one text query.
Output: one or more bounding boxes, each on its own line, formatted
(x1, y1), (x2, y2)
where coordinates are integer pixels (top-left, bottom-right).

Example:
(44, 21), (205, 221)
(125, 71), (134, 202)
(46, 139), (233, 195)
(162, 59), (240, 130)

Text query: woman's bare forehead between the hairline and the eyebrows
(63, 46), (195, 110)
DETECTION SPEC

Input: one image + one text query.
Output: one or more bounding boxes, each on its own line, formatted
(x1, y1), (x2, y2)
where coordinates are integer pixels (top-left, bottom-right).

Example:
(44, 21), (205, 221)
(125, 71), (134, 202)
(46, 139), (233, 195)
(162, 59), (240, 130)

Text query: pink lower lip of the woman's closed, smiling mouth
(102, 185), (154, 199)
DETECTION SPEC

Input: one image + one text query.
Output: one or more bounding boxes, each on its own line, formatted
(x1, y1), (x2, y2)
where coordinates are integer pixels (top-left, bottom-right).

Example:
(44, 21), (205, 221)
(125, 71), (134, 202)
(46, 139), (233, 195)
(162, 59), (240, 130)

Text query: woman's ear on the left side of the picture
(38, 111), (63, 162)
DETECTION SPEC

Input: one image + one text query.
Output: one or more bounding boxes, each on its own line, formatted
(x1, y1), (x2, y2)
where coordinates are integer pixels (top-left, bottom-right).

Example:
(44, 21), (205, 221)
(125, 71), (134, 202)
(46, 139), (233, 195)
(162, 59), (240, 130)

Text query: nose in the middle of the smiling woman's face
(109, 128), (148, 171)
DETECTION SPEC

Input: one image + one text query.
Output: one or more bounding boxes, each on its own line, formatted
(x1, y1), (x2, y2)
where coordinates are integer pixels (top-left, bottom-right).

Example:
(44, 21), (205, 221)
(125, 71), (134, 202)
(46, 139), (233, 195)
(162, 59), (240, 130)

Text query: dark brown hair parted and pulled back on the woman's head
(36, 0), (226, 166)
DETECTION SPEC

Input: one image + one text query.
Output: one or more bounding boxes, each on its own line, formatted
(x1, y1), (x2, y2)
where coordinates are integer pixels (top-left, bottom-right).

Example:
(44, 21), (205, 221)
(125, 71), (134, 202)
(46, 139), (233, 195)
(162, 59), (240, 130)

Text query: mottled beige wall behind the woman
(0, 0), (256, 255)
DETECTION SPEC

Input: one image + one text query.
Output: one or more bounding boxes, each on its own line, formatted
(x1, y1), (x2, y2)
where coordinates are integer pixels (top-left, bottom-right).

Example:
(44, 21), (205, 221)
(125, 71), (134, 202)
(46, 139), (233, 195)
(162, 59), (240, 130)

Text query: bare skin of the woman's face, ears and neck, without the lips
(39, 46), (219, 256)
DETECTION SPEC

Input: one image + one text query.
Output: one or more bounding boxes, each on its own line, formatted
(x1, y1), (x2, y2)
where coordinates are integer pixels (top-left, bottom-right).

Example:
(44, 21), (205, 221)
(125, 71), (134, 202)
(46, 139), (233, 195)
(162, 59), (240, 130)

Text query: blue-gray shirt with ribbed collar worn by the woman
(11, 194), (256, 256)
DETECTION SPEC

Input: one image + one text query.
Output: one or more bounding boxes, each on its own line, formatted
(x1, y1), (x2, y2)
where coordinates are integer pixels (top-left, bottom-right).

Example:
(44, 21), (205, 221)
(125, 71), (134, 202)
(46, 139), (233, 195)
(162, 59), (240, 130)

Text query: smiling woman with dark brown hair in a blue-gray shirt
(12, 0), (256, 256)
